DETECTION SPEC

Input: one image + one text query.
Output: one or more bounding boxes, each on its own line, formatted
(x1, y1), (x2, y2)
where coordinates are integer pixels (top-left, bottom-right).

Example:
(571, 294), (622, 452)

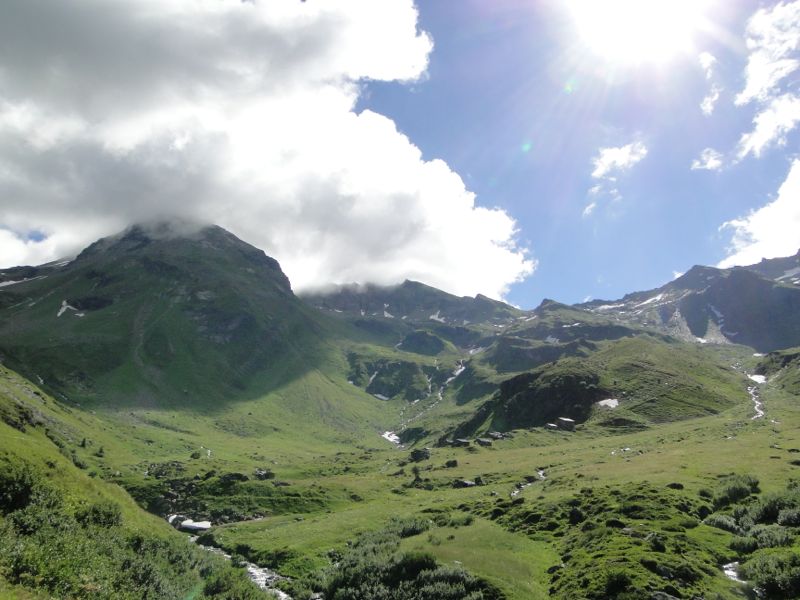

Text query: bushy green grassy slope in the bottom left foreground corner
(0, 367), (266, 600)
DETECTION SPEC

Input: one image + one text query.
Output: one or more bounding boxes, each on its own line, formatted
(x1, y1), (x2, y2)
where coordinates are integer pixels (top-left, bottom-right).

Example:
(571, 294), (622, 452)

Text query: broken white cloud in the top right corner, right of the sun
(735, 0), (800, 160)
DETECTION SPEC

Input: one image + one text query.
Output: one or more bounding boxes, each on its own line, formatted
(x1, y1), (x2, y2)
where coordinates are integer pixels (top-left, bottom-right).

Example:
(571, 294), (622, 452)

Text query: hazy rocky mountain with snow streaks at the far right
(577, 254), (800, 352)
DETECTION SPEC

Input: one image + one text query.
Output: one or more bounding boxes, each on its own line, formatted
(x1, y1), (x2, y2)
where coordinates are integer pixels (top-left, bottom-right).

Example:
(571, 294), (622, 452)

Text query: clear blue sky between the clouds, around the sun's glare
(360, 0), (800, 307)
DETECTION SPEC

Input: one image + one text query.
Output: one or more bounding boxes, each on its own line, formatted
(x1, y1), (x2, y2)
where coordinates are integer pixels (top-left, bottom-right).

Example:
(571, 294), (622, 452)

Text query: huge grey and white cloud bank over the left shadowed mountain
(0, 0), (535, 297)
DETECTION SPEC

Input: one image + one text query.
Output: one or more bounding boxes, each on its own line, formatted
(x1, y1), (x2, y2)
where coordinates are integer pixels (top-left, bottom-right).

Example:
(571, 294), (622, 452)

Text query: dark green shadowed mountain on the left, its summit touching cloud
(0, 223), (322, 406)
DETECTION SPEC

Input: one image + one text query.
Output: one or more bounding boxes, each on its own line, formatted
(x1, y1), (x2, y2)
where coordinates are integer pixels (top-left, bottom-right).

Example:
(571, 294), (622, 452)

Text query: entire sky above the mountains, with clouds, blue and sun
(0, 0), (800, 308)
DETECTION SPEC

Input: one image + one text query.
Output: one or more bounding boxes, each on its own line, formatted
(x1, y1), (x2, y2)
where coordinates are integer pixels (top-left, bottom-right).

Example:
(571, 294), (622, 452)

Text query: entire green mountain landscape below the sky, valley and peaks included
(0, 222), (800, 600)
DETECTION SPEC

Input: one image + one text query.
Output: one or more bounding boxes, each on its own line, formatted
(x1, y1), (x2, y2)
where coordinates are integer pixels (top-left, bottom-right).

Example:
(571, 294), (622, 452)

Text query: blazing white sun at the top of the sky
(568, 0), (710, 64)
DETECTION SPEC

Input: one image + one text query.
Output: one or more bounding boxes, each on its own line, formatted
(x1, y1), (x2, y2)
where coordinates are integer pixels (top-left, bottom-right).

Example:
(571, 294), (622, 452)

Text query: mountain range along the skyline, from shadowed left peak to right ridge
(0, 223), (800, 437)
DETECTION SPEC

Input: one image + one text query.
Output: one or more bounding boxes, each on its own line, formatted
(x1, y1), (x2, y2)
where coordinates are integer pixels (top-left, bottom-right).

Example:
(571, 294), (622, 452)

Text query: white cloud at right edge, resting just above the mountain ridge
(719, 160), (800, 268)
